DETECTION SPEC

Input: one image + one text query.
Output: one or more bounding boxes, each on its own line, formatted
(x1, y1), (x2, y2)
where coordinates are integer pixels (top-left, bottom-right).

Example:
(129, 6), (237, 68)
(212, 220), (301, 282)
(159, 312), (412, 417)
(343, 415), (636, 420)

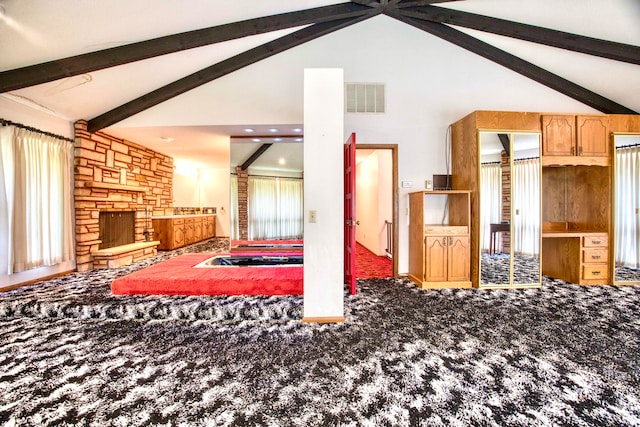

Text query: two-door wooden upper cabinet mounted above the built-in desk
(541, 115), (609, 166)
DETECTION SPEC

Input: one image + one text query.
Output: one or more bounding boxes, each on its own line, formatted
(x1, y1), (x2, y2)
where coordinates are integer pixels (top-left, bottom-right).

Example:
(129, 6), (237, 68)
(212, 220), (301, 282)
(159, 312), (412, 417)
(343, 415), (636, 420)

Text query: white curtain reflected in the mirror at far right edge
(615, 146), (640, 268)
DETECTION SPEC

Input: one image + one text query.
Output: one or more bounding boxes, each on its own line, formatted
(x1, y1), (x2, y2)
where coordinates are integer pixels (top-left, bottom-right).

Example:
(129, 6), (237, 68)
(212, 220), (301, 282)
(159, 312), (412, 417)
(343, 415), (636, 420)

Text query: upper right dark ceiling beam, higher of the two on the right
(402, 6), (640, 65)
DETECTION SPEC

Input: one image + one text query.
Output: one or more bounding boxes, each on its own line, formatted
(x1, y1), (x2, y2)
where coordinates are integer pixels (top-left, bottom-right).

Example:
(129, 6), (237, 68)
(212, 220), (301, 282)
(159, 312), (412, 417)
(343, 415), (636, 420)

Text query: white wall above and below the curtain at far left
(0, 96), (76, 287)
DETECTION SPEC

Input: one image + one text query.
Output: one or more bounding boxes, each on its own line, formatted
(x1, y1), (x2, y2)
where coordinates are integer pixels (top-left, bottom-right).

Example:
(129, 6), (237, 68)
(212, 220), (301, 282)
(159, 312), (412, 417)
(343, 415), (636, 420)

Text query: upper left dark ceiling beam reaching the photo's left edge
(0, 2), (371, 93)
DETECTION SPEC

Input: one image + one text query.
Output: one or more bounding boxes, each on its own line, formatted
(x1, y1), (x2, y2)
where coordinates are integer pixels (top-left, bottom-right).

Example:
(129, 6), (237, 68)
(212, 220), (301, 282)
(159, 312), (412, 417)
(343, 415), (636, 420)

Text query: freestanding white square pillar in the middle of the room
(304, 69), (345, 319)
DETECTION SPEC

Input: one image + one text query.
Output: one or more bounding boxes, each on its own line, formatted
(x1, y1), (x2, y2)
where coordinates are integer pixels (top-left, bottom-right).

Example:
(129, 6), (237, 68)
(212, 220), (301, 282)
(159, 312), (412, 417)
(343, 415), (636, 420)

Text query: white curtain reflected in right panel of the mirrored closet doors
(511, 159), (540, 256)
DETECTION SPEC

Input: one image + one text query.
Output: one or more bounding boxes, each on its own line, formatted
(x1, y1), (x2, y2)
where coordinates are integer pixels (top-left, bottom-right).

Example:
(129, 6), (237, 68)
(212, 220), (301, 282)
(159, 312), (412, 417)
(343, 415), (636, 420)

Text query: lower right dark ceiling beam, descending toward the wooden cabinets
(393, 12), (638, 114)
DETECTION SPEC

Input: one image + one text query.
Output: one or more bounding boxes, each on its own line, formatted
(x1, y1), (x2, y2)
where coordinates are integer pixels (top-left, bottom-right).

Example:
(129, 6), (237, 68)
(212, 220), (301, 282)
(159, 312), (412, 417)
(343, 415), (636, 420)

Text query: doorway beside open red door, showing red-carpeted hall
(356, 144), (398, 277)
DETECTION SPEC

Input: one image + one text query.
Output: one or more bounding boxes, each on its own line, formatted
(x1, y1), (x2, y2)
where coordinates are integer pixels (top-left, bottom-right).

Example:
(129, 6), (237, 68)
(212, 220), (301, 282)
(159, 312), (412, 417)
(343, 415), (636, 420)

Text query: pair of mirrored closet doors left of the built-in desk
(479, 131), (541, 287)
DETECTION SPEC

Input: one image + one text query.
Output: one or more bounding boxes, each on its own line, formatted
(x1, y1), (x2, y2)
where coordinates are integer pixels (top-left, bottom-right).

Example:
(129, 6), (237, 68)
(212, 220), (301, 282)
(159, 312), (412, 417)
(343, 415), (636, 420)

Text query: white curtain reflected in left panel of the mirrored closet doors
(480, 163), (502, 252)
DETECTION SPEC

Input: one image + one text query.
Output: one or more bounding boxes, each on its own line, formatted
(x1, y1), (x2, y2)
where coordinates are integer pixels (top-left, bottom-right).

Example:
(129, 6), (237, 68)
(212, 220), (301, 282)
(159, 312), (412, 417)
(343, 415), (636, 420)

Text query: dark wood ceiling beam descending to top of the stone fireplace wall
(88, 13), (378, 132)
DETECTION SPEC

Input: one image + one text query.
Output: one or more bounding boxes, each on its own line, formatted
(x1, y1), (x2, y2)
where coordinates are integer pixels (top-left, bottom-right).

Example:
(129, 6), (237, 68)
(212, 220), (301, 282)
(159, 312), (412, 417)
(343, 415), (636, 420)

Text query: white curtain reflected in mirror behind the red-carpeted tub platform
(247, 176), (304, 240)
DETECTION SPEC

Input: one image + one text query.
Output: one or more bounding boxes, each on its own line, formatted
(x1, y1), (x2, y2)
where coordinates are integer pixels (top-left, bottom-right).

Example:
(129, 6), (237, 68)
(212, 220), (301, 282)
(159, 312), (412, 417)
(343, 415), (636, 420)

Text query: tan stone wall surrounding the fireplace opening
(73, 120), (173, 271)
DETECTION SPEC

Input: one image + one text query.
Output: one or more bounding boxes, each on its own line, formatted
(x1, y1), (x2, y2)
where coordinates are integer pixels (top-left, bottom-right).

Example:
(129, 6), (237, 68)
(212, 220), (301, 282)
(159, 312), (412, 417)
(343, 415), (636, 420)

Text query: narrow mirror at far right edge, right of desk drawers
(614, 135), (640, 283)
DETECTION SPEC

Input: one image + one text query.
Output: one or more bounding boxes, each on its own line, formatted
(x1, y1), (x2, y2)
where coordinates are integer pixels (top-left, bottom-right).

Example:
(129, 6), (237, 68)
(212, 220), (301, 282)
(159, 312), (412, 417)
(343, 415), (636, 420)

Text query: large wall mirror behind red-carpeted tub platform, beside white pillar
(230, 136), (304, 249)
